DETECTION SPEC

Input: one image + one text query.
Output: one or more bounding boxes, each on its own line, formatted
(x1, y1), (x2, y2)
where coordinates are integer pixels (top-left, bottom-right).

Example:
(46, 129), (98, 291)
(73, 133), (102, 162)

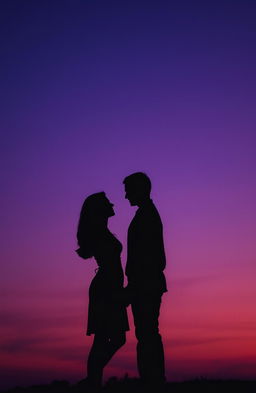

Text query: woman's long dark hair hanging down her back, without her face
(77, 192), (106, 259)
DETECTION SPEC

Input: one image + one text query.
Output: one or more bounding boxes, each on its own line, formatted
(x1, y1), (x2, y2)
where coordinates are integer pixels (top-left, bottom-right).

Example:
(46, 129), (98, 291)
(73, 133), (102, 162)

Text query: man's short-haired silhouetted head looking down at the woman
(123, 172), (151, 206)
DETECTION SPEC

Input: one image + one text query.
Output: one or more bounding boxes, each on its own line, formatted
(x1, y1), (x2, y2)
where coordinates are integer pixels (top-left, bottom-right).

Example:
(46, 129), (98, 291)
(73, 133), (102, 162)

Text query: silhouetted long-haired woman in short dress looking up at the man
(77, 192), (129, 389)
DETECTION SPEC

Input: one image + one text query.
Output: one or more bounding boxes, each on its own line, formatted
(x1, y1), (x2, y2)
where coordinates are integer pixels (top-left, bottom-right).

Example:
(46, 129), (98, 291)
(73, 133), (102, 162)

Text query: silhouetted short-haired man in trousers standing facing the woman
(123, 172), (167, 385)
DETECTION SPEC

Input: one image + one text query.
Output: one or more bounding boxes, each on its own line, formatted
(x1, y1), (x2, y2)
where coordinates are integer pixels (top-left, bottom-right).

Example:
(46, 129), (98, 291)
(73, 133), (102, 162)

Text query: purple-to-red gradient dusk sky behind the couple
(0, 0), (256, 388)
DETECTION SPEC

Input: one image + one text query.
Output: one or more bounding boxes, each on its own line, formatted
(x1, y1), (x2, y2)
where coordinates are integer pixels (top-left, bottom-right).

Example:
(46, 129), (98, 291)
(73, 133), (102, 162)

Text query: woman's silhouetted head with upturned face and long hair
(77, 192), (115, 258)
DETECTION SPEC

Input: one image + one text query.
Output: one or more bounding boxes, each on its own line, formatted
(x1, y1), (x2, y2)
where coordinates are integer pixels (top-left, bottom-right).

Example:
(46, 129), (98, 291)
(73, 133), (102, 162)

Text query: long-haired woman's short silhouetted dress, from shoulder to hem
(87, 230), (129, 335)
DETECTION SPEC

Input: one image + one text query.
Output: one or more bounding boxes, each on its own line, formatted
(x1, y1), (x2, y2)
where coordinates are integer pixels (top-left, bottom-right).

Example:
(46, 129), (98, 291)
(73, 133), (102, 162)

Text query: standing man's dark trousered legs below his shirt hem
(132, 294), (165, 384)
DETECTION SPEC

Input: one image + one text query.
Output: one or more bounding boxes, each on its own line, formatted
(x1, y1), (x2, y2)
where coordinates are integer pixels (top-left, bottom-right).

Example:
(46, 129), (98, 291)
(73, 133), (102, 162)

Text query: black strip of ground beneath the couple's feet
(3, 377), (256, 393)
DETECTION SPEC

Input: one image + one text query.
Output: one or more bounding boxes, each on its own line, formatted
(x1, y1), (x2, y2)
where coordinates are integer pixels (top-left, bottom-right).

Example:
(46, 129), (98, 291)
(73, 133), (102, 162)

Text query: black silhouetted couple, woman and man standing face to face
(77, 172), (167, 390)
